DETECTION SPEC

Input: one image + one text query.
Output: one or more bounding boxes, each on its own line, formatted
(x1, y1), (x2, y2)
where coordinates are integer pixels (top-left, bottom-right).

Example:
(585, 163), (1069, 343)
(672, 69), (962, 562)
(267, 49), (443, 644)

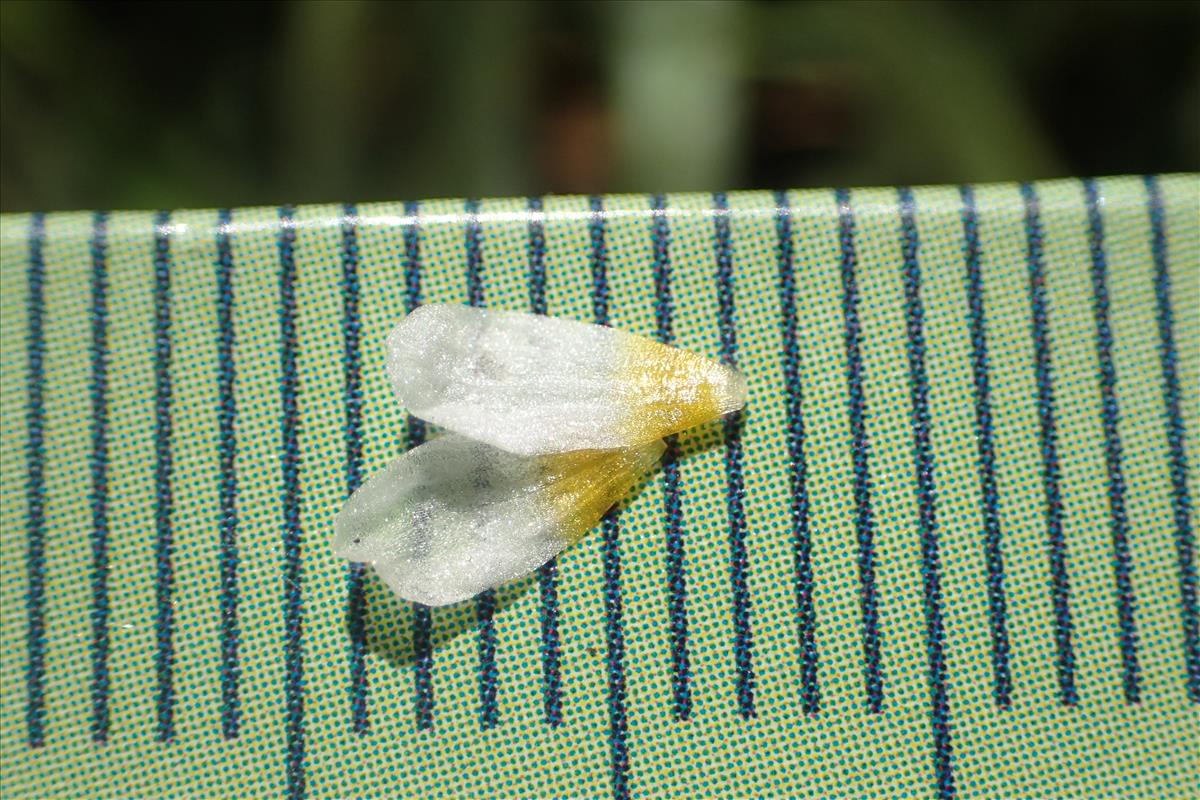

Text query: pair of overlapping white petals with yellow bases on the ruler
(334, 305), (748, 606)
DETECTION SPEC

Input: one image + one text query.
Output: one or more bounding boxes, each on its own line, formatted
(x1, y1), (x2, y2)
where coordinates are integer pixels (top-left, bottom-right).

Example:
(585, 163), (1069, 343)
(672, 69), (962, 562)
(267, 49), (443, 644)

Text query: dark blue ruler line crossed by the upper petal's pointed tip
(713, 192), (755, 720)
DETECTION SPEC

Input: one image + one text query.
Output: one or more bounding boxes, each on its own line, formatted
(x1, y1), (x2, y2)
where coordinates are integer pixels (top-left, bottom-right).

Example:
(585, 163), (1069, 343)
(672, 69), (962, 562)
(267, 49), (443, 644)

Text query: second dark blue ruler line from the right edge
(1084, 180), (1139, 703)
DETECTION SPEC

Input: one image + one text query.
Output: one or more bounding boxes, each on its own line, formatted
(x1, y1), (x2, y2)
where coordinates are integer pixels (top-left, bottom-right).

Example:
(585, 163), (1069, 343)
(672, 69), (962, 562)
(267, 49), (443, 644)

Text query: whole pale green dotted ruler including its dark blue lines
(0, 176), (1200, 798)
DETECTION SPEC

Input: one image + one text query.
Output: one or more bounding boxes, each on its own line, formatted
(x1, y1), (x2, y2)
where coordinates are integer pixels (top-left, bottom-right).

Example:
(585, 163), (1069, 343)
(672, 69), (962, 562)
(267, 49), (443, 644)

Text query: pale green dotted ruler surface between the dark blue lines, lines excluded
(0, 175), (1200, 798)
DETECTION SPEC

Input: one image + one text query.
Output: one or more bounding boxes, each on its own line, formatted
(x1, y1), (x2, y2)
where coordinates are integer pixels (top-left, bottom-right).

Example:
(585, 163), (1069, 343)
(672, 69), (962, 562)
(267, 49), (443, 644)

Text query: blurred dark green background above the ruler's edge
(0, 1), (1200, 211)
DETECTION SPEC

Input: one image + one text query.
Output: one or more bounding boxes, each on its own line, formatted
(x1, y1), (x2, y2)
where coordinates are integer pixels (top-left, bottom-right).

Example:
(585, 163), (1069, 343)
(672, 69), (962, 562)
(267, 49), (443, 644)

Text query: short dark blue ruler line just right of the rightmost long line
(959, 186), (1013, 709)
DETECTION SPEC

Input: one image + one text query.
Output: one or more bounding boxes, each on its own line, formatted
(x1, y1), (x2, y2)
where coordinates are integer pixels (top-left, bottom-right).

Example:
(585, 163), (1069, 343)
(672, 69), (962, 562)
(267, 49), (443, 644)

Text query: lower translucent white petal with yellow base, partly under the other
(334, 433), (664, 606)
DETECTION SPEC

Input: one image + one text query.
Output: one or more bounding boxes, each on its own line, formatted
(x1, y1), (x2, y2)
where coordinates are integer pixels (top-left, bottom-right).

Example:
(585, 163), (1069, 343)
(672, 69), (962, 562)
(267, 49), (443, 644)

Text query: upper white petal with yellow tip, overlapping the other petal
(388, 305), (746, 455)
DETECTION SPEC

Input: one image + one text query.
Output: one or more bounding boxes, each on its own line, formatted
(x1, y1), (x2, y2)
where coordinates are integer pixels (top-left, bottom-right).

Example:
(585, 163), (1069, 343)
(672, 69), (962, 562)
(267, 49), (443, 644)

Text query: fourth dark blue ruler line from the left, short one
(217, 209), (241, 739)
